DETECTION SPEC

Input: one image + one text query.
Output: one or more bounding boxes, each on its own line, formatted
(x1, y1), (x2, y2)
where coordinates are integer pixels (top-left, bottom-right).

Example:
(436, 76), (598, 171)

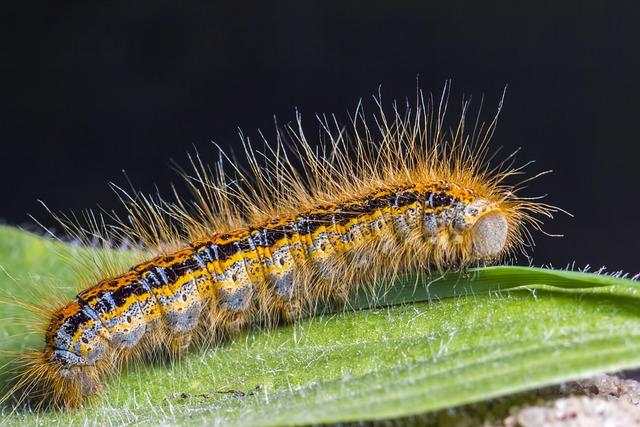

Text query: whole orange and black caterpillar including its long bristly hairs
(4, 86), (556, 409)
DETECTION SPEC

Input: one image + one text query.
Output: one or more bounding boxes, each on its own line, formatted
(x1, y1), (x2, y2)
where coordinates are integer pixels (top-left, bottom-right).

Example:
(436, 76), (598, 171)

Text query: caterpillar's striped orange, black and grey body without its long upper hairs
(31, 181), (509, 407)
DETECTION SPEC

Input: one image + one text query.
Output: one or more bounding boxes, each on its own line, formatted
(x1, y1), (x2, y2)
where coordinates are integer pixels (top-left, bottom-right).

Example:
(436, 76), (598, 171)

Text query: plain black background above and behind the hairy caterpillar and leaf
(0, 0), (640, 273)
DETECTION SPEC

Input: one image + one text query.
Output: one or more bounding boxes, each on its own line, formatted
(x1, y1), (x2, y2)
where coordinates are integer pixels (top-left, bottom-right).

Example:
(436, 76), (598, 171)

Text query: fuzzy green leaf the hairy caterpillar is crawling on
(0, 227), (640, 425)
